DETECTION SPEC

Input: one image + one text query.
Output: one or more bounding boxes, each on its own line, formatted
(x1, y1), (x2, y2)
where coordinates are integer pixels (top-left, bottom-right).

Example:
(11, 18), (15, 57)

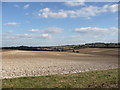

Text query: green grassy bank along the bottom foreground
(2, 69), (118, 88)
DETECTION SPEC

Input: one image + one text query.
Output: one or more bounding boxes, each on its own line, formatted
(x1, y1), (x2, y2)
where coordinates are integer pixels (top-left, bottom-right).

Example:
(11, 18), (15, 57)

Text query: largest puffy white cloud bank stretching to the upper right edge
(38, 4), (118, 18)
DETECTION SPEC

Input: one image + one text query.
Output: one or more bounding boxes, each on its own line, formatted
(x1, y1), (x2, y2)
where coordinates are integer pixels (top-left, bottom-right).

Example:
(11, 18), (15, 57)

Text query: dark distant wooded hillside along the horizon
(2, 43), (120, 51)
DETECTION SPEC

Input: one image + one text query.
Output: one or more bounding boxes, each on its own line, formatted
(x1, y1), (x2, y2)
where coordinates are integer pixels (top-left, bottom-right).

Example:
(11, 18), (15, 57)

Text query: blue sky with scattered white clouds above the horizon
(2, 2), (118, 46)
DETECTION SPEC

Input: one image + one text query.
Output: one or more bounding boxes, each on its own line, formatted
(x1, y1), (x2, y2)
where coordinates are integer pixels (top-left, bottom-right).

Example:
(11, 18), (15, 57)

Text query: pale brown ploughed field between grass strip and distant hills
(1, 48), (118, 78)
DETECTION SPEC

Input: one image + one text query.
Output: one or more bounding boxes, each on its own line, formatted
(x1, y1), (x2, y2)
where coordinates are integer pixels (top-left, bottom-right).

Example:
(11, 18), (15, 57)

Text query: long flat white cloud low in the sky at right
(74, 27), (118, 36)
